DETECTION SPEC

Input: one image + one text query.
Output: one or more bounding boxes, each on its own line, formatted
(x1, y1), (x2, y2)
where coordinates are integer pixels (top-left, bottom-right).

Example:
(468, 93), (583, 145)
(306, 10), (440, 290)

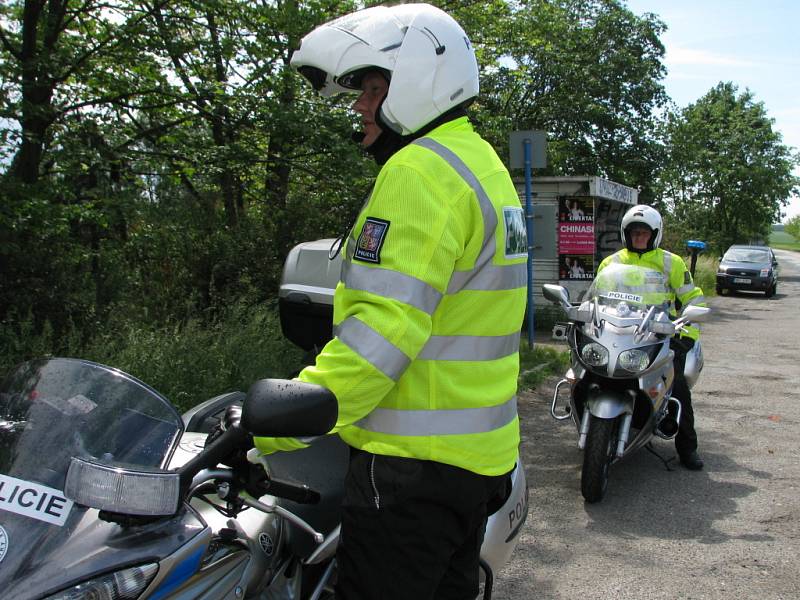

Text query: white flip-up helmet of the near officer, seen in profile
(291, 4), (478, 136)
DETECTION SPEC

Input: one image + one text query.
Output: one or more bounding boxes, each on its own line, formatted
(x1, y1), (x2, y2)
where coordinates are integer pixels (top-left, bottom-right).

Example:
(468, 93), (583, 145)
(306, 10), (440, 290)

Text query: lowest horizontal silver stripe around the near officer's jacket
(354, 396), (517, 436)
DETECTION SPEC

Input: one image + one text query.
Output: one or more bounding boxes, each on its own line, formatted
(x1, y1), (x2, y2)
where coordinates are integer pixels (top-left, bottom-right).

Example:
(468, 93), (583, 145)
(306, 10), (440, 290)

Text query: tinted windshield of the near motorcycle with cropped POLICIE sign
(0, 358), (183, 597)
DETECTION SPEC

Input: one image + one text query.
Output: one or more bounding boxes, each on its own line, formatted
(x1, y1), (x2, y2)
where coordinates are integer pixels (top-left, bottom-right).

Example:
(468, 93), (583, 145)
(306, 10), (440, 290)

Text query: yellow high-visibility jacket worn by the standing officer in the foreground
(282, 117), (527, 475)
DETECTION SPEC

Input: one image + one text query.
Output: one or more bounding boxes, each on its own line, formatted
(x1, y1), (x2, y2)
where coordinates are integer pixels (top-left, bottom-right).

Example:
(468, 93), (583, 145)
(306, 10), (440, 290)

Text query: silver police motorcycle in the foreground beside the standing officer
(0, 358), (526, 600)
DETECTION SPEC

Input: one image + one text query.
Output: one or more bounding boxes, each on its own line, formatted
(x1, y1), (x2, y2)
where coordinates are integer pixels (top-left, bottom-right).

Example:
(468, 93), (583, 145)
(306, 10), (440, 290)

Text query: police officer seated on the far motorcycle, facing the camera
(597, 204), (706, 471)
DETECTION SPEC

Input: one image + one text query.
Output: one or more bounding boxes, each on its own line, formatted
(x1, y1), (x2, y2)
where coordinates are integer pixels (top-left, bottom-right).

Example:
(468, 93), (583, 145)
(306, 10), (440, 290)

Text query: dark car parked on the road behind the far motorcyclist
(717, 245), (778, 298)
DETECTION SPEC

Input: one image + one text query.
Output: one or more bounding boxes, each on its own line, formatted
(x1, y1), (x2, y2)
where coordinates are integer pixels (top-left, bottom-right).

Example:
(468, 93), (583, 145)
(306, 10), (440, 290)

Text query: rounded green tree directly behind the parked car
(662, 83), (800, 250)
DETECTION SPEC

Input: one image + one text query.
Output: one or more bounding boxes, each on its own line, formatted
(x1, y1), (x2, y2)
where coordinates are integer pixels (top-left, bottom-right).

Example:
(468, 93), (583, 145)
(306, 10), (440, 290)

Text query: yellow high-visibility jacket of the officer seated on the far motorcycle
(597, 248), (706, 340)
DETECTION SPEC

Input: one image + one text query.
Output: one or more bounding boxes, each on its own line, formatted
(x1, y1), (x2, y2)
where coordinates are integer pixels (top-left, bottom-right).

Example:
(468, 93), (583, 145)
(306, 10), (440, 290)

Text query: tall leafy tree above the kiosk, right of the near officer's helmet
(464, 0), (667, 201)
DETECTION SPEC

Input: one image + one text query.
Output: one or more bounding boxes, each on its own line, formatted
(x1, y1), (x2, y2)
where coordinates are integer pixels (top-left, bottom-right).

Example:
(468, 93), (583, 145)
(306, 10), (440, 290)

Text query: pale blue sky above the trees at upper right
(627, 0), (800, 220)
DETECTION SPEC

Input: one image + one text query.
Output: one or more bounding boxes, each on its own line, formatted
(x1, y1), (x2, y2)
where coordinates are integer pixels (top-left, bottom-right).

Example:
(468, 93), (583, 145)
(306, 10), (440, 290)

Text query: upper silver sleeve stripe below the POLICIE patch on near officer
(342, 261), (442, 315)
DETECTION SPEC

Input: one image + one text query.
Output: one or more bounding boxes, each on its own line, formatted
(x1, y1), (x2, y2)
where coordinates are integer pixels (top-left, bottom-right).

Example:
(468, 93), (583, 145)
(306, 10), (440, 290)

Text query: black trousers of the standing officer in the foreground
(336, 449), (510, 600)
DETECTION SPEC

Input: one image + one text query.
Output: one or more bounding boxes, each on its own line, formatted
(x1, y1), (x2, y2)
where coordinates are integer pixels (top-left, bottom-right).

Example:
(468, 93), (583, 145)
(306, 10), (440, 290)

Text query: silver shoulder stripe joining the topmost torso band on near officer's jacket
(413, 137), (528, 294)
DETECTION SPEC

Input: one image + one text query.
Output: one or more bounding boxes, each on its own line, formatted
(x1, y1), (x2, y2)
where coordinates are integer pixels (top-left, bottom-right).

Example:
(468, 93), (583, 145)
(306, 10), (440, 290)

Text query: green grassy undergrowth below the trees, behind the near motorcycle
(0, 304), (302, 411)
